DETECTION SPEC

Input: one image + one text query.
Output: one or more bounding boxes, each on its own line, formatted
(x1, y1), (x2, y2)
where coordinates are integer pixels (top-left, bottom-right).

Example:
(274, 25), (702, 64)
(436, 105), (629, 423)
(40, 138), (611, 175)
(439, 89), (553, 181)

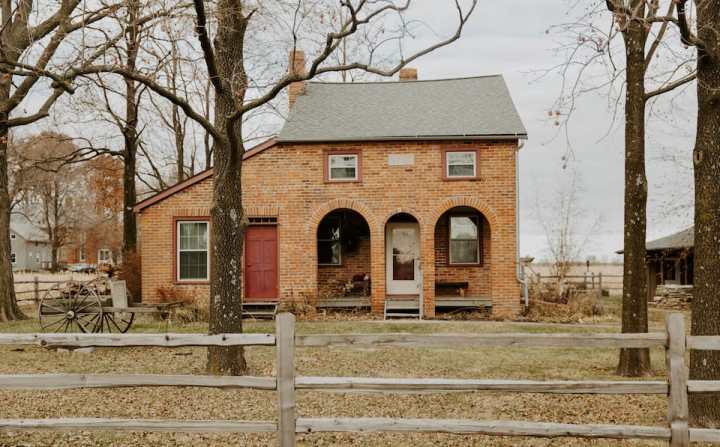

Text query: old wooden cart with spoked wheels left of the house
(38, 278), (182, 333)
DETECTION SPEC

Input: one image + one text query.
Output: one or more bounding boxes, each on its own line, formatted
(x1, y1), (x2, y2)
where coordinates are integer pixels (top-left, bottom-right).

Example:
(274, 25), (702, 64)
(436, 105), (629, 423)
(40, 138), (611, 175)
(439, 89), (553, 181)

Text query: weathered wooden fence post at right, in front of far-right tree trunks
(665, 313), (690, 447)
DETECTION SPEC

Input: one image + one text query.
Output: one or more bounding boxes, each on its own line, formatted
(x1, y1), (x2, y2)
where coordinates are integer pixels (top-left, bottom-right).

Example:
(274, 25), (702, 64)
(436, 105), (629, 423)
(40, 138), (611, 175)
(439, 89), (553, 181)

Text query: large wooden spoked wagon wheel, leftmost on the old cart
(38, 282), (103, 333)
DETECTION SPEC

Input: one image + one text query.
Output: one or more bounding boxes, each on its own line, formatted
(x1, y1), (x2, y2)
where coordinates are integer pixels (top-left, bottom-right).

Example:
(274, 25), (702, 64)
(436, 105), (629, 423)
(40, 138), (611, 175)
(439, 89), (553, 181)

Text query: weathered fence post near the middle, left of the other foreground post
(275, 312), (296, 447)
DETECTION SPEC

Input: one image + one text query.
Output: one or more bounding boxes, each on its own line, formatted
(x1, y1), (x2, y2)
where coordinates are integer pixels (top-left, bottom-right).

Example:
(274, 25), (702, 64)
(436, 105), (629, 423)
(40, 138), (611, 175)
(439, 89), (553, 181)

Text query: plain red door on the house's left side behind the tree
(245, 226), (278, 301)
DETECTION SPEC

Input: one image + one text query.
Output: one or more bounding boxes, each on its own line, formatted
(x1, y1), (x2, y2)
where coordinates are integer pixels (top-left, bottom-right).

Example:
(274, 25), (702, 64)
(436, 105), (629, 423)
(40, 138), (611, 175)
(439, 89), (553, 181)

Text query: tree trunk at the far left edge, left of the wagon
(0, 117), (25, 321)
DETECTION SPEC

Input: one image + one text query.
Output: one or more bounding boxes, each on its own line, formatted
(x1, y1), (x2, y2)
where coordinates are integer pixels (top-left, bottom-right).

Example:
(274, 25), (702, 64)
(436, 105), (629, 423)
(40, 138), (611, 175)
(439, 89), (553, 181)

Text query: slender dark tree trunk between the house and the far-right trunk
(617, 11), (650, 377)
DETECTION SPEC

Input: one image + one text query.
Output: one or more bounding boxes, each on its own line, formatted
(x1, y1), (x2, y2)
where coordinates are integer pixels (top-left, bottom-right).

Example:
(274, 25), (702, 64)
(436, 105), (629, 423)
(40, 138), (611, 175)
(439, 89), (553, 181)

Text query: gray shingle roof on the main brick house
(278, 75), (527, 142)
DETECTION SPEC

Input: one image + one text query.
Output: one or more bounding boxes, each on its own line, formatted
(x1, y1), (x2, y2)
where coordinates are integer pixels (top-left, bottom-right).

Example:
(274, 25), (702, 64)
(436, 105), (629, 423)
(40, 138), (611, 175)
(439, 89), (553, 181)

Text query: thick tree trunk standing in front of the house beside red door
(207, 0), (247, 375)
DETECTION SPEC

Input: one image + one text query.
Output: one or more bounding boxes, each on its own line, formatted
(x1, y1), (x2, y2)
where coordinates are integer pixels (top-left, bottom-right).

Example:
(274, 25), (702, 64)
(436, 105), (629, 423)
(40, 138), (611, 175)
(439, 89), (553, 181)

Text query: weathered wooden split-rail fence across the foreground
(0, 314), (720, 446)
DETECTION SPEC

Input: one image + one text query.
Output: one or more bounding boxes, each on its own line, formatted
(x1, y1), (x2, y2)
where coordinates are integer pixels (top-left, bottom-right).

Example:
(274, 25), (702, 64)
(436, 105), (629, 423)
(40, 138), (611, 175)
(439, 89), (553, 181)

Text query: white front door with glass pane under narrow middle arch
(385, 222), (422, 295)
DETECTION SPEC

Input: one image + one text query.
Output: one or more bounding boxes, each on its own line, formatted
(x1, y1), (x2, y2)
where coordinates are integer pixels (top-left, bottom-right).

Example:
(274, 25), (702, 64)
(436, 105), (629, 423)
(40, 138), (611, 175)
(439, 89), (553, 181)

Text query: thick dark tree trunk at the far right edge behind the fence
(689, 0), (720, 427)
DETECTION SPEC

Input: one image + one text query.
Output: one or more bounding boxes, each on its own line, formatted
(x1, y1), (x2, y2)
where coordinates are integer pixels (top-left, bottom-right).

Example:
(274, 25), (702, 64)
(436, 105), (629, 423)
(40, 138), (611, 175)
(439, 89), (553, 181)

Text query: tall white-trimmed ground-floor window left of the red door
(177, 221), (210, 281)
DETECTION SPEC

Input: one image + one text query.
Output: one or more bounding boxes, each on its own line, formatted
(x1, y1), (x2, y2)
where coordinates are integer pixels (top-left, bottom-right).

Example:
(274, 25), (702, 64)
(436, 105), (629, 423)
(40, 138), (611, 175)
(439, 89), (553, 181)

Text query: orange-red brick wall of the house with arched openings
(140, 141), (520, 316)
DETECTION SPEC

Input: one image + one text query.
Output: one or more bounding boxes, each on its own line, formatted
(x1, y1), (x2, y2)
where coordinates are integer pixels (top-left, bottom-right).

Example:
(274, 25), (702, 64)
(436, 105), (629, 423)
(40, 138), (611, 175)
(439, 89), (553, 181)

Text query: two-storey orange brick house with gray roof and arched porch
(135, 55), (526, 317)
